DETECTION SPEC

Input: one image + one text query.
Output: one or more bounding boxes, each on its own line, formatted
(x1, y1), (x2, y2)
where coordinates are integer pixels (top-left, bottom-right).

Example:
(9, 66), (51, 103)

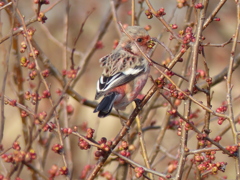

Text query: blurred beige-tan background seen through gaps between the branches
(0, 0), (239, 179)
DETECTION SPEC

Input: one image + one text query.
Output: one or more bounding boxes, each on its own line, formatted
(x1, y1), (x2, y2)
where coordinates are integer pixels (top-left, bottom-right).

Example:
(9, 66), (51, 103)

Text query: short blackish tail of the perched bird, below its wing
(93, 92), (117, 118)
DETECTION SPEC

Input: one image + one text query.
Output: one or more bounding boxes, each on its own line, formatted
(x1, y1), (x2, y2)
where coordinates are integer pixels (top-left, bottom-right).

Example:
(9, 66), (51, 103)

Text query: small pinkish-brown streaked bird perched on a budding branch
(93, 26), (152, 118)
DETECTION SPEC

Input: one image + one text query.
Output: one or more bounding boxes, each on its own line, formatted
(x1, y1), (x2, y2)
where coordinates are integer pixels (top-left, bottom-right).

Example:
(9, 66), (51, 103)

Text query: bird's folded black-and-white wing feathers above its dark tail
(95, 66), (146, 99)
